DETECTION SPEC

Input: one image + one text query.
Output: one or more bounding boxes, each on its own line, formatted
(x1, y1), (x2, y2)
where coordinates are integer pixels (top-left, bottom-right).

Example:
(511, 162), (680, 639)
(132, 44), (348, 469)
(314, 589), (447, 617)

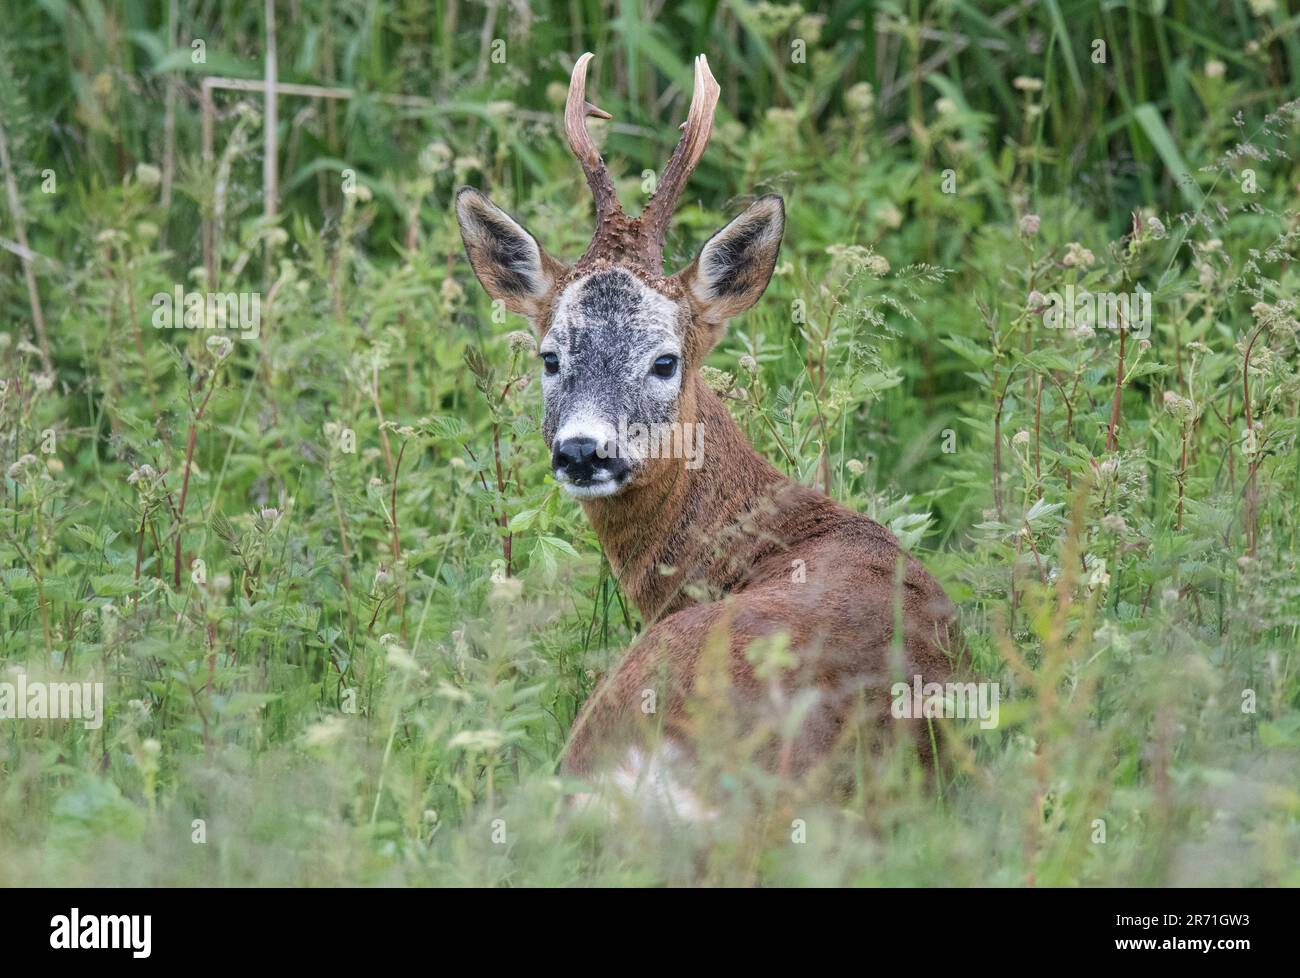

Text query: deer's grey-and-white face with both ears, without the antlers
(456, 189), (784, 498)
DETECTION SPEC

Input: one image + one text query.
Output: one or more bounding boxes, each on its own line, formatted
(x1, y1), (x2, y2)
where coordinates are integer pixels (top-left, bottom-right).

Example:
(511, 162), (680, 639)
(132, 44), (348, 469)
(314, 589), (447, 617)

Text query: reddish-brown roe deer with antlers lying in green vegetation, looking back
(456, 53), (954, 814)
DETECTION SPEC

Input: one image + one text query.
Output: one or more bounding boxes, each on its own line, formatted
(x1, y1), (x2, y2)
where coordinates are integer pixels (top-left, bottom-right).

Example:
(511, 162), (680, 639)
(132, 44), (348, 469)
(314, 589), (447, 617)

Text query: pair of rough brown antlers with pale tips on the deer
(564, 52), (722, 277)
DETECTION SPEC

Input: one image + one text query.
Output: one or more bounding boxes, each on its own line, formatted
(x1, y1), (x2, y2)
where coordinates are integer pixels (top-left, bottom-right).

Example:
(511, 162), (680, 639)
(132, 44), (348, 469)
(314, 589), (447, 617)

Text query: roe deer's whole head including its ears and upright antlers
(456, 53), (785, 498)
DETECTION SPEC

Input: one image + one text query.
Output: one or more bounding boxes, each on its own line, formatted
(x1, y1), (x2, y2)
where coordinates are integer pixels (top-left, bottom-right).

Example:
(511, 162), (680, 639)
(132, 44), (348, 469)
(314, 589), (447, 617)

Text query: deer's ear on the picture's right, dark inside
(681, 194), (785, 326)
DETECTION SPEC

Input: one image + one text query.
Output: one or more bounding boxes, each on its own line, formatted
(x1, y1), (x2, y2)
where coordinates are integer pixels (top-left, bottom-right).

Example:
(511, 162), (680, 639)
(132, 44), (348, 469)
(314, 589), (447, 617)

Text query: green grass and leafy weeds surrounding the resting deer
(0, 0), (1300, 887)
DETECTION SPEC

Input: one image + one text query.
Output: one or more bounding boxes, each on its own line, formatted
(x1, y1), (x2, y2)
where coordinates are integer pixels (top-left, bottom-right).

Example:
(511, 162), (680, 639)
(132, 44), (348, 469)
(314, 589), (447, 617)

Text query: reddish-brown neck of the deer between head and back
(582, 375), (785, 623)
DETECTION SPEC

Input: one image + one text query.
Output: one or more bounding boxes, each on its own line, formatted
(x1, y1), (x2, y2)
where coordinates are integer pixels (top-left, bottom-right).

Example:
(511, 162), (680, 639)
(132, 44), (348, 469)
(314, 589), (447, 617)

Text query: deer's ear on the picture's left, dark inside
(456, 187), (564, 325)
